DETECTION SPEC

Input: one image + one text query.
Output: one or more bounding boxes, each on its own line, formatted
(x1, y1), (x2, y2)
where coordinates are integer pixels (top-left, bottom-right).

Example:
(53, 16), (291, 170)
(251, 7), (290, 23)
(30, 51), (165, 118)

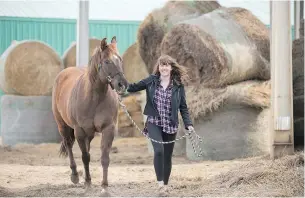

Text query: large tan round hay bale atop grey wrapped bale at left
(0, 40), (63, 96)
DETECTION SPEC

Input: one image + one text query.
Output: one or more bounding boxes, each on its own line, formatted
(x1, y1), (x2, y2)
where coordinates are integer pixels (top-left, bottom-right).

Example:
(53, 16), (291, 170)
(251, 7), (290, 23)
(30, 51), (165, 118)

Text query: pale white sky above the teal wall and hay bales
(0, 0), (300, 24)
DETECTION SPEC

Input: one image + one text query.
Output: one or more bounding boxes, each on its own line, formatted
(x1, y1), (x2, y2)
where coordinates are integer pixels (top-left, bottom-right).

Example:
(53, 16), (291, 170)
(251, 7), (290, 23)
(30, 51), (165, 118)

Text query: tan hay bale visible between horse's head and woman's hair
(122, 43), (149, 83)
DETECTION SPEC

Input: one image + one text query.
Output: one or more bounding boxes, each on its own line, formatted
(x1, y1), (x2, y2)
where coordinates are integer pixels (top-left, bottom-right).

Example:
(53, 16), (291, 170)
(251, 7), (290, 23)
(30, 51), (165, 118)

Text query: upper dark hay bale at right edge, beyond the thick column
(292, 38), (304, 96)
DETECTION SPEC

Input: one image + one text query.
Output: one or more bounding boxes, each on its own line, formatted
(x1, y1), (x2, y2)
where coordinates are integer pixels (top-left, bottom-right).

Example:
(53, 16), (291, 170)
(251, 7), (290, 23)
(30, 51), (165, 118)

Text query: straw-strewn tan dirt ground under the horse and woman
(0, 136), (304, 197)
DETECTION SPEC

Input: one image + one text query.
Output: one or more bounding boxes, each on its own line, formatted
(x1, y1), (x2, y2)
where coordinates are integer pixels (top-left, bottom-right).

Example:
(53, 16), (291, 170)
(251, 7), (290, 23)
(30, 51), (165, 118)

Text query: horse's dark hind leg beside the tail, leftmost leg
(60, 125), (79, 184)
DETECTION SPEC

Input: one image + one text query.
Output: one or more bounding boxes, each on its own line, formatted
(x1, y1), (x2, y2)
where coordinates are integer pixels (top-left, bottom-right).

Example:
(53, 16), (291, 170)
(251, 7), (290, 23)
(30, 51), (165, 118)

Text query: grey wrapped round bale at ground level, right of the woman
(186, 104), (269, 160)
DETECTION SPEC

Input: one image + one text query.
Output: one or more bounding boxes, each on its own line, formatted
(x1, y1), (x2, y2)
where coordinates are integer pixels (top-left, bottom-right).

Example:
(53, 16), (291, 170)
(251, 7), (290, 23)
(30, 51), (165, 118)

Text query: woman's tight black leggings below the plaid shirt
(147, 122), (176, 185)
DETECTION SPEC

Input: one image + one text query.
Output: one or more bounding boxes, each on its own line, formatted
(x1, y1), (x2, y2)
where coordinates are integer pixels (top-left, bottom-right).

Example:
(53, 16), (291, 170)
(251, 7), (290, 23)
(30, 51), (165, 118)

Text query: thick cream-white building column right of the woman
(270, 1), (294, 159)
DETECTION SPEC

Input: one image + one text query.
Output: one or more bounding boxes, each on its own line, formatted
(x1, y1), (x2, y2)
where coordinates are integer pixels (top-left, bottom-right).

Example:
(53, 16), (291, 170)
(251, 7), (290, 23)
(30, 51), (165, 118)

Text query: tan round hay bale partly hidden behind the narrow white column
(62, 38), (101, 68)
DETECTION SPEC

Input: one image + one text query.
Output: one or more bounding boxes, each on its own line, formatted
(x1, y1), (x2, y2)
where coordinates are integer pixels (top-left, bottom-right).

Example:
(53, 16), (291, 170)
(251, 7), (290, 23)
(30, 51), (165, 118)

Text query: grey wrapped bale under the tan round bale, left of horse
(1, 95), (61, 145)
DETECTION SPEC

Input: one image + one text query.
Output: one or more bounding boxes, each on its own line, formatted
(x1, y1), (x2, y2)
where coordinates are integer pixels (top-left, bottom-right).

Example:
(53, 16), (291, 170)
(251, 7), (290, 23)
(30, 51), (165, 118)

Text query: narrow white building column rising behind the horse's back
(76, 0), (89, 67)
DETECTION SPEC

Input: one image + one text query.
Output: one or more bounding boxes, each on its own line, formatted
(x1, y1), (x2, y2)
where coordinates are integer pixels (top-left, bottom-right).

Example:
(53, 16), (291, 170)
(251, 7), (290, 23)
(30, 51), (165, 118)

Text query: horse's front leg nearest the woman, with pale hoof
(101, 124), (116, 194)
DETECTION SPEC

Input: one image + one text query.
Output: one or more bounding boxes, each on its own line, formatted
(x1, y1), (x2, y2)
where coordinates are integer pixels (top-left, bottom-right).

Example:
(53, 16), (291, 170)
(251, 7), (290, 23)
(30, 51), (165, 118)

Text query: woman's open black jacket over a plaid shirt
(127, 75), (193, 129)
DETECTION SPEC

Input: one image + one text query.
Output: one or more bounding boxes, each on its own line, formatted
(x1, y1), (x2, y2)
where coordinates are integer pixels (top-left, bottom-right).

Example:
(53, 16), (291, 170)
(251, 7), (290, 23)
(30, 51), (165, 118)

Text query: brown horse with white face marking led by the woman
(52, 37), (128, 192)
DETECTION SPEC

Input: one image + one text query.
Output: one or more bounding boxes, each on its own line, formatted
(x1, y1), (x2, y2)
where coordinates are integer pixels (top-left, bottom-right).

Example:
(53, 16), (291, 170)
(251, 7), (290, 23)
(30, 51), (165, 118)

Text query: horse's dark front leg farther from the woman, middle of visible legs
(75, 127), (94, 187)
